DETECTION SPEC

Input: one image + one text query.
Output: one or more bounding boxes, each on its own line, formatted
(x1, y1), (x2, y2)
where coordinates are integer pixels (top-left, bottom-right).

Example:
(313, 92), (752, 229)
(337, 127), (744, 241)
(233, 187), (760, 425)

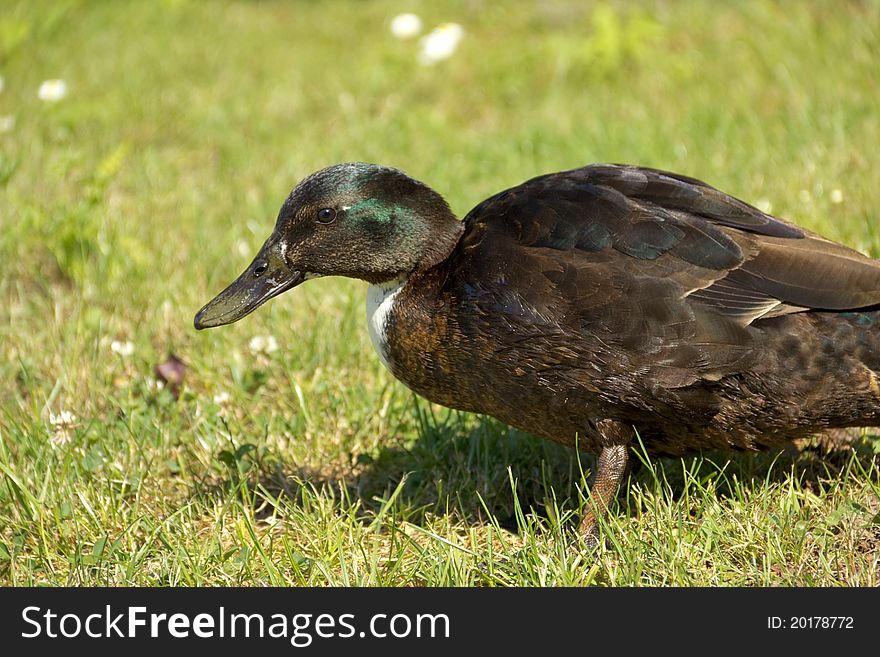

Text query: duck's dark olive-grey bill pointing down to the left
(193, 257), (305, 330)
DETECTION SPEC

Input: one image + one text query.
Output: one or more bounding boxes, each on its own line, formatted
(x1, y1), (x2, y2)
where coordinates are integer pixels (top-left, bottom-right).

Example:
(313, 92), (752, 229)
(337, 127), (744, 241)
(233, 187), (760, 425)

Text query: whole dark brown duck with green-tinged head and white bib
(195, 162), (880, 541)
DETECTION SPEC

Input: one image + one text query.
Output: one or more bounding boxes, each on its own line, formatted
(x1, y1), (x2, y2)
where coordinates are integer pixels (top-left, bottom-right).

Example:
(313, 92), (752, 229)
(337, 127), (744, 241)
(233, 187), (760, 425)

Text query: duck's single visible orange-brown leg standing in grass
(581, 420), (632, 545)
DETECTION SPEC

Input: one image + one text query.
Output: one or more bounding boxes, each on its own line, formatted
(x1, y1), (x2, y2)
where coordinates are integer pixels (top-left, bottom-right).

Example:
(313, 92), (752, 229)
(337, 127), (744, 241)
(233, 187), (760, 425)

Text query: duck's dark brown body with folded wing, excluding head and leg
(368, 167), (880, 455)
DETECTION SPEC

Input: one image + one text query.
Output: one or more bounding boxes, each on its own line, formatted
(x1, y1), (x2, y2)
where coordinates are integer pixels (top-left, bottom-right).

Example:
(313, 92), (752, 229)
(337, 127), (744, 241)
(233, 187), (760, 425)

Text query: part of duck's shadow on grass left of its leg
(261, 413), (591, 531)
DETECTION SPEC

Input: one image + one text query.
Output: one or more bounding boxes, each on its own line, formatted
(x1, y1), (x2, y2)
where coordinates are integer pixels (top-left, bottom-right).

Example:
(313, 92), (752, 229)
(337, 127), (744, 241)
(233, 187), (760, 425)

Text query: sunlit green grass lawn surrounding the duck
(0, 0), (880, 586)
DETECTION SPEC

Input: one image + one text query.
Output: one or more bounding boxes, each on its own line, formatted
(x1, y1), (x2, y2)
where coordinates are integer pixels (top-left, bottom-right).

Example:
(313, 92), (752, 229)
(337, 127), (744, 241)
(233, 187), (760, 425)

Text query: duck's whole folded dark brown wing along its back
(451, 165), (880, 384)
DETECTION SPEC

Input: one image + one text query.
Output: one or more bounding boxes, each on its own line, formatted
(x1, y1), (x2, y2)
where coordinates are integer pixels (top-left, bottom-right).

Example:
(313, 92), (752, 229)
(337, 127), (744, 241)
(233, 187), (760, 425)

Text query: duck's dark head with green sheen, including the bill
(195, 162), (463, 329)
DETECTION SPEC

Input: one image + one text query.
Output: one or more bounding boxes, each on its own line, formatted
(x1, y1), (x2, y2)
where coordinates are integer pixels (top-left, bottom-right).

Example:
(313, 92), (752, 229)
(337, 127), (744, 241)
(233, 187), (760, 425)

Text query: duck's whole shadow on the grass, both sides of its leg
(201, 408), (878, 532)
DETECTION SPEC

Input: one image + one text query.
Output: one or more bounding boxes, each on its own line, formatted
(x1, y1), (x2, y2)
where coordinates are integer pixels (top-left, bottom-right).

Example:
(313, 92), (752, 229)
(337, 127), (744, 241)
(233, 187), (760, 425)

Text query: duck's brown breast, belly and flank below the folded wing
(377, 258), (880, 456)
